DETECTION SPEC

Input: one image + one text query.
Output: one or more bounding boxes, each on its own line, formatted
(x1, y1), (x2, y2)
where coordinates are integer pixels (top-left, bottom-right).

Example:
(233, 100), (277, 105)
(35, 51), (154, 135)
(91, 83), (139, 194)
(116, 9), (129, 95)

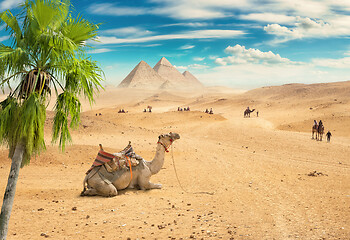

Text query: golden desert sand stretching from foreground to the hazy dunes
(0, 82), (350, 240)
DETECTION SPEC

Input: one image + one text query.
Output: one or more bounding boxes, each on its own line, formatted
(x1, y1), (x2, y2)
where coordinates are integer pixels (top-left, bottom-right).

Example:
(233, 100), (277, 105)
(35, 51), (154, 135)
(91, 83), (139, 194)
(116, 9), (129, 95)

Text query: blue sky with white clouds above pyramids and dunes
(0, 0), (350, 89)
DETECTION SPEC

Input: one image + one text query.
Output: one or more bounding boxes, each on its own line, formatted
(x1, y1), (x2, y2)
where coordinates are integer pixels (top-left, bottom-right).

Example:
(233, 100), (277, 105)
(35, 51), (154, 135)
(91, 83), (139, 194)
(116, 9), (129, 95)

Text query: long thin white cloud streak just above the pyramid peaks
(96, 29), (245, 44)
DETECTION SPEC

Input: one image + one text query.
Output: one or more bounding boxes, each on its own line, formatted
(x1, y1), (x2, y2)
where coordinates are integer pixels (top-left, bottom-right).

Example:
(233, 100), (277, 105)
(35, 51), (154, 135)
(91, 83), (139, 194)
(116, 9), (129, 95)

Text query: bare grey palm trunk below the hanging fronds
(0, 143), (25, 240)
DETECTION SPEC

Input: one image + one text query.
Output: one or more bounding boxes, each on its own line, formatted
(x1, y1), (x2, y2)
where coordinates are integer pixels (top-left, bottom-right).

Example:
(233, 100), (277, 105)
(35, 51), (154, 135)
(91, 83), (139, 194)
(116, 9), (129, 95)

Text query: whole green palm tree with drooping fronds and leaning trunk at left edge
(0, 0), (103, 240)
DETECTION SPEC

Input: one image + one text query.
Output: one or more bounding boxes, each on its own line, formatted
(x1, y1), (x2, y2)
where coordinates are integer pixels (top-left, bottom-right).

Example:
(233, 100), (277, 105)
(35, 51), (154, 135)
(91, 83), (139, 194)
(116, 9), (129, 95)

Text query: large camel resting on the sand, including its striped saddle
(81, 132), (180, 197)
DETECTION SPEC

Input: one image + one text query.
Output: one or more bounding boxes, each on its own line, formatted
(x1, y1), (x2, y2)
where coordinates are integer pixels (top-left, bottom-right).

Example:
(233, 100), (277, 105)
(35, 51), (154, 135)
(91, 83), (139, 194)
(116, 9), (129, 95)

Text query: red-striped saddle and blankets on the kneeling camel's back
(86, 141), (143, 174)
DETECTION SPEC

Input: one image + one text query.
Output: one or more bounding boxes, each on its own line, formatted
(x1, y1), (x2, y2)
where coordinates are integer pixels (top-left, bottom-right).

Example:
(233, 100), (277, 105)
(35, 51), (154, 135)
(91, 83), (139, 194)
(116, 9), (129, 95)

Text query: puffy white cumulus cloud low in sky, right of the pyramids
(215, 44), (293, 66)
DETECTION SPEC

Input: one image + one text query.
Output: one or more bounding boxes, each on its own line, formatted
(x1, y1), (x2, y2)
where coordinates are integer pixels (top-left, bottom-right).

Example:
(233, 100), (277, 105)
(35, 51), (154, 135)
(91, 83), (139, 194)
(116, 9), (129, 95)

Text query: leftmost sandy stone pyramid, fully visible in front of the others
(118, 61), (165, 89)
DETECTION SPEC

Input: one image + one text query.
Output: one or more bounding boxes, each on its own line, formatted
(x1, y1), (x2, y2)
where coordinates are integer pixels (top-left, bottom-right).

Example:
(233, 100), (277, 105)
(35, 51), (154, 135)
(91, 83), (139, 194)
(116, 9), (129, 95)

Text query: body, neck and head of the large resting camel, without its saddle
(81, 132), (180, 197)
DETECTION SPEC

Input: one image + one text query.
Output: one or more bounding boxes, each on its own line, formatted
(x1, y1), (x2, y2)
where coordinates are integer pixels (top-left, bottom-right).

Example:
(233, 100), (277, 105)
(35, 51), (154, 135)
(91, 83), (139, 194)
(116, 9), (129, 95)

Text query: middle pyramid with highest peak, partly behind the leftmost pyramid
(153, 57), (188, 88)
